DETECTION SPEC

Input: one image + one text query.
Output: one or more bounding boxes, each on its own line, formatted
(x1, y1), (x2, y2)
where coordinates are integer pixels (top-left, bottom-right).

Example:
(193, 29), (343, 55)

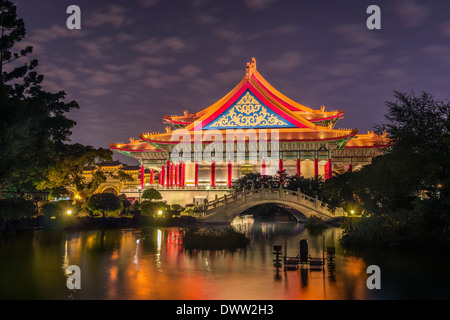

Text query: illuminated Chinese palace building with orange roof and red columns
(110, 58), (387, 189)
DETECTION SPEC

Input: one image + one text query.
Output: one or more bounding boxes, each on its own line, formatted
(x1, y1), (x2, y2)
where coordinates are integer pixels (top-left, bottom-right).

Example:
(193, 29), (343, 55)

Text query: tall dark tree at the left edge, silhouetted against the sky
(0, 0), (79, 190)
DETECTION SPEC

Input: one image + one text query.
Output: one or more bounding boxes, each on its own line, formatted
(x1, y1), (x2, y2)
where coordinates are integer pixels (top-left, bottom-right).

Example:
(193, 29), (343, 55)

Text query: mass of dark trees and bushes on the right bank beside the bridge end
(342, 92), (450, 246)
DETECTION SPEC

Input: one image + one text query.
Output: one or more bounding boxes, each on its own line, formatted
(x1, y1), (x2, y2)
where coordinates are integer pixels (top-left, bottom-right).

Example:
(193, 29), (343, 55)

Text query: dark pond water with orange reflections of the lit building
(0, 219), (450, 300)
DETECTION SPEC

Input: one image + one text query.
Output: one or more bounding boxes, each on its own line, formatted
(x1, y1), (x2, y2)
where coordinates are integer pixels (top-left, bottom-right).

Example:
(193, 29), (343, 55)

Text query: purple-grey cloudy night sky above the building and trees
(9, 0), (450, 164)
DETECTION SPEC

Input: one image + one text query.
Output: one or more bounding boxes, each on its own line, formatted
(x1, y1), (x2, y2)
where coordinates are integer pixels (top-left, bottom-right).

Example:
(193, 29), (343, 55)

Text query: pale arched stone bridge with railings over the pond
(200, 187), (344, 222)
